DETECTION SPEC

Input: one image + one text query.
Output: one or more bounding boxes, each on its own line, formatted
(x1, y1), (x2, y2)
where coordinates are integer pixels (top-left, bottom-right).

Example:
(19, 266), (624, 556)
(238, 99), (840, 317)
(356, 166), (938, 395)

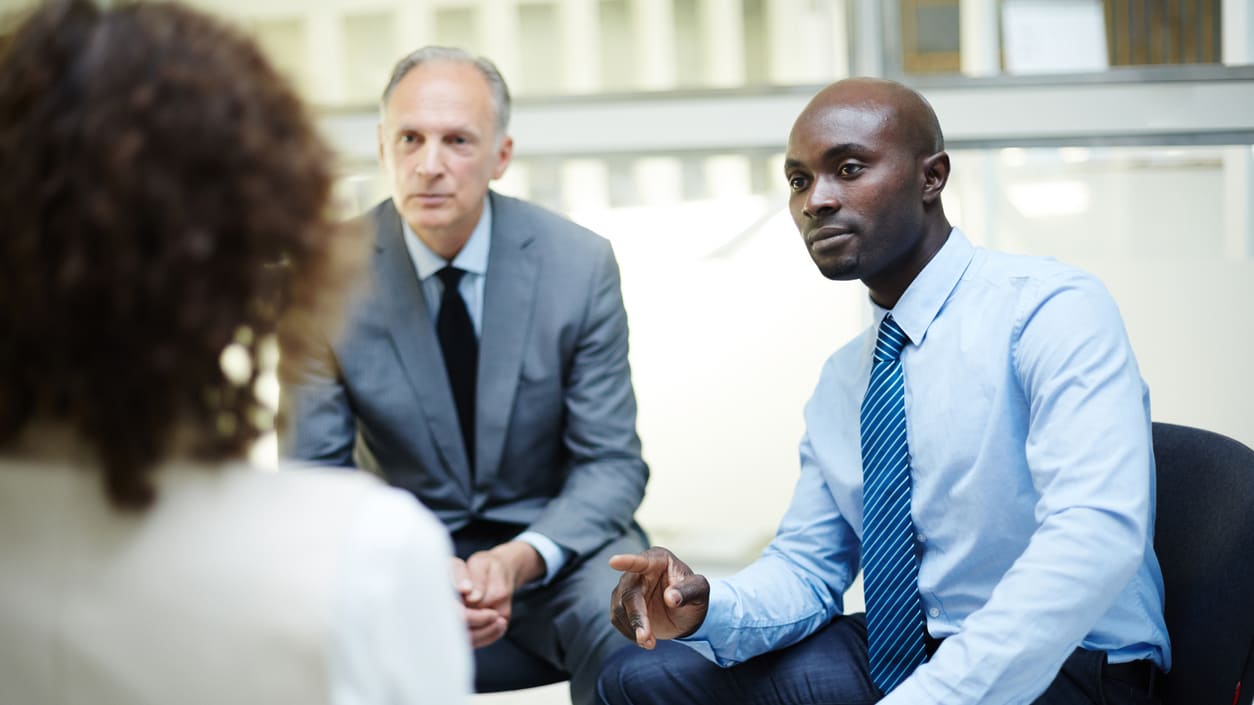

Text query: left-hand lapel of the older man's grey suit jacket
(374, 201), (483, 497)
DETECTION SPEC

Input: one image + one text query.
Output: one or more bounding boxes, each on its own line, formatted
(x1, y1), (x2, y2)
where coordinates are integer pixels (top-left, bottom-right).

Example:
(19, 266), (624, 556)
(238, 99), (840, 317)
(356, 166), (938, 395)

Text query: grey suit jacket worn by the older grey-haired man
(285, 193), (648, 556)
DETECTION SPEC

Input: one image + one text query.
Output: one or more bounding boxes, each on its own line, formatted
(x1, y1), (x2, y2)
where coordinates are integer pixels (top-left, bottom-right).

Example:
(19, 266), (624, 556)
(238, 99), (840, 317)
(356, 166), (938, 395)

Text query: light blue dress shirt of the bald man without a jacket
(683, 228), (1170, 705)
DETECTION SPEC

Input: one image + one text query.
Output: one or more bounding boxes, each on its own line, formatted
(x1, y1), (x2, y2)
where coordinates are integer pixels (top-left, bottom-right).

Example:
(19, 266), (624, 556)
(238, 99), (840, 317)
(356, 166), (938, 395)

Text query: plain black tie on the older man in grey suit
(435, 267), (479, 472)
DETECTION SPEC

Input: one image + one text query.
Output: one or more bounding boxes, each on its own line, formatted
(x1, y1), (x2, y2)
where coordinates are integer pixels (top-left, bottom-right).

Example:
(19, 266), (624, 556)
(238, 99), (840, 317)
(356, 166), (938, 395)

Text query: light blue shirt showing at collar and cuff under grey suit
(401, 196), (568, 585)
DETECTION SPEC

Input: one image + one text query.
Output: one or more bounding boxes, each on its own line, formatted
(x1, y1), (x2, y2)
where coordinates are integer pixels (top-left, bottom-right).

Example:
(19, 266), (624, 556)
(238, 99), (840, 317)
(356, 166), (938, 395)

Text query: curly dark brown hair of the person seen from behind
(0, 0), (361, 509)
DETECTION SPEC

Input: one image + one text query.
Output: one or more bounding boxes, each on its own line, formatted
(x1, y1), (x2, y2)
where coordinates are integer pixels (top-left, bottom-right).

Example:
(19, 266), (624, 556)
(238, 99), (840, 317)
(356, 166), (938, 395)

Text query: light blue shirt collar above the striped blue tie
(868, 228), (976, 345)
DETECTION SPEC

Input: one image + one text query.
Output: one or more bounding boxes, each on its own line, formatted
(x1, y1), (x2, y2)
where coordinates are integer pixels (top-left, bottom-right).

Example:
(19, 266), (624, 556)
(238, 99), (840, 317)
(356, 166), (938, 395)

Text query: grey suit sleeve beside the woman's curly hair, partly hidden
(280, 328), (356, 468)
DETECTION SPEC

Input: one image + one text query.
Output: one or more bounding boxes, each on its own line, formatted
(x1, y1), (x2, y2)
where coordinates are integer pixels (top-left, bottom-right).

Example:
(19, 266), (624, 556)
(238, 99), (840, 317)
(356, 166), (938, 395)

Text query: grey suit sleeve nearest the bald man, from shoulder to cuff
(530, 238), (648, 554)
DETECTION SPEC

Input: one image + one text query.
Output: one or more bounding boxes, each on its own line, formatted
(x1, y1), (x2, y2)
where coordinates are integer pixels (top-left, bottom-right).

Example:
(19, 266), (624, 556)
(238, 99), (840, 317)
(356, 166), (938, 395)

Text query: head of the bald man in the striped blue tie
(784, 78), (951, 309)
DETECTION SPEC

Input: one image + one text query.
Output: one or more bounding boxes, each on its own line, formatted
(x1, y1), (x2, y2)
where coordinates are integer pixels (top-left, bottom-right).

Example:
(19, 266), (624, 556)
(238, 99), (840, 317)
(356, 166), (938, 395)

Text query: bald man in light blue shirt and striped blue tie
(598, 79), (1170, 705)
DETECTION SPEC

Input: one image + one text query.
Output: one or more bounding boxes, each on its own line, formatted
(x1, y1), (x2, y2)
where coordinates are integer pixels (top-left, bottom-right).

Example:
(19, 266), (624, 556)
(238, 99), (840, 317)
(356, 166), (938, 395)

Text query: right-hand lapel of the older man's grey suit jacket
(475, 193), (539, 487)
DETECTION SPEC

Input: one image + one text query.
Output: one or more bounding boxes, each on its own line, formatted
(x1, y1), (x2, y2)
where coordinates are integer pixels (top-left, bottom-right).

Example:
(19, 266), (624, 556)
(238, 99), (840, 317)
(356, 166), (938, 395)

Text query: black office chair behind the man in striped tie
(1154, 423), (1254, 705)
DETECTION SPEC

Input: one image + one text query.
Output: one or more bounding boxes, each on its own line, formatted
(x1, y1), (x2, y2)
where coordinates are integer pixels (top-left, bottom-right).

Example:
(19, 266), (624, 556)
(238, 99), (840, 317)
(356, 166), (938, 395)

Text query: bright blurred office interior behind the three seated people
(0, 0), (1254, 704)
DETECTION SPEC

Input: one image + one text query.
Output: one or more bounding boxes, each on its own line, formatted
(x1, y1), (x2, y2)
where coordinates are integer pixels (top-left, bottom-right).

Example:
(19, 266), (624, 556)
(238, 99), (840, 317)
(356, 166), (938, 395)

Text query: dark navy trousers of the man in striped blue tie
(598, 615), (1159, 705)
